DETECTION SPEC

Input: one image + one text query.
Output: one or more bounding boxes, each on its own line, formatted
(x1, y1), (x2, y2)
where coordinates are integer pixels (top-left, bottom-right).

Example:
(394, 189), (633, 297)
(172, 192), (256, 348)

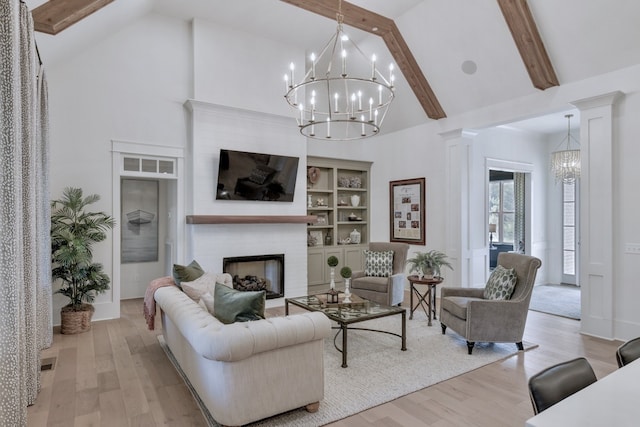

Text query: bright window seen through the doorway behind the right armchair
(489, 179), (515, 244)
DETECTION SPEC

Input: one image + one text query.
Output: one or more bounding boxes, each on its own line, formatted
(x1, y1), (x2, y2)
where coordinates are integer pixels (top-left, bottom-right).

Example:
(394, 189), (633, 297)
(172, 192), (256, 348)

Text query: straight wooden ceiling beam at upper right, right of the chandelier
(498, 0), (560, 90)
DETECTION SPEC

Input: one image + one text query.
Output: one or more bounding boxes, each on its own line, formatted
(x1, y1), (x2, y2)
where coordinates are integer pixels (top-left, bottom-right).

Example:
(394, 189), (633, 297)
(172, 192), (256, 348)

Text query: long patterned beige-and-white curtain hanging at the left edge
(0, 0), (52, 426)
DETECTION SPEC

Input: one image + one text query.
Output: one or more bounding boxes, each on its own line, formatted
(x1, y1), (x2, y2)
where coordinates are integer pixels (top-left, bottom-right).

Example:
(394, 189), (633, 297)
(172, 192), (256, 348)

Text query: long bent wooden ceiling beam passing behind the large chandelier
(281, 0), (446, 120)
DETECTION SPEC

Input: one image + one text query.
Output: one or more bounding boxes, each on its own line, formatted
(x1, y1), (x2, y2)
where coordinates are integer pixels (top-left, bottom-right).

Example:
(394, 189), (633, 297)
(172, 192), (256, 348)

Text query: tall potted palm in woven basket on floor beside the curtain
(51, 187), (115, 334)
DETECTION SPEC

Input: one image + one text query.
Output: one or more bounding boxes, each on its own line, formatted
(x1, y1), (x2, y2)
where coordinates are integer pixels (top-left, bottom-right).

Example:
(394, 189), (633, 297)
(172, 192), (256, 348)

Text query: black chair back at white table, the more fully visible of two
(529, 357), (597, 414)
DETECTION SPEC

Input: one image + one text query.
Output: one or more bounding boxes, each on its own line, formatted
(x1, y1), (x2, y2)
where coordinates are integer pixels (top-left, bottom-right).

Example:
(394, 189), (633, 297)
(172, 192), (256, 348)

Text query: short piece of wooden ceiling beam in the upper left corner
(31, 0), (113, 35)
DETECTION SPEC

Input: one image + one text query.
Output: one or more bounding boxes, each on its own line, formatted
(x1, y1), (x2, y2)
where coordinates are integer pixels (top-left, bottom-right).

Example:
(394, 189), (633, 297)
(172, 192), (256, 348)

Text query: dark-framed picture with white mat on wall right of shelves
(389, 178), (426, 245)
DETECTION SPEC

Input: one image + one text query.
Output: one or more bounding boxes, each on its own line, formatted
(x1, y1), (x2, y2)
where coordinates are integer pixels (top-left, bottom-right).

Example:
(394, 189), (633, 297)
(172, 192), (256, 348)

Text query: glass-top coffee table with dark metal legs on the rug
(284, 292), (407, 368)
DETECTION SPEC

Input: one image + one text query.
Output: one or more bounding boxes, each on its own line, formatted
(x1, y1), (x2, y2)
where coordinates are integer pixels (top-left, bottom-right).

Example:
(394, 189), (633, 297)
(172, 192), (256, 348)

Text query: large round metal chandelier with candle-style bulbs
(284, 0), (395, 141)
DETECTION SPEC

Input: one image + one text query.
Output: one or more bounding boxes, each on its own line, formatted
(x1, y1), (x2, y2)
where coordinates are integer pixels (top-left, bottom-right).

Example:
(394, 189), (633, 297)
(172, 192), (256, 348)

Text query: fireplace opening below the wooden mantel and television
(222, 254), (284, 299)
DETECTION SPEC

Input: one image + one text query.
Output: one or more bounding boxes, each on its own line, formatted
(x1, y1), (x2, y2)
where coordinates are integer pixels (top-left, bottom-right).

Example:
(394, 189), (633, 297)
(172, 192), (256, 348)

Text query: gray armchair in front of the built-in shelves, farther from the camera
(351, 242), (409, 305)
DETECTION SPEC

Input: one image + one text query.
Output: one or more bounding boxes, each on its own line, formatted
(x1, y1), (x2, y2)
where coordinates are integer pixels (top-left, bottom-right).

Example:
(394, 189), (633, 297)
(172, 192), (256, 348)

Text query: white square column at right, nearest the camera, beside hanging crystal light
(572, 92), (623, 338)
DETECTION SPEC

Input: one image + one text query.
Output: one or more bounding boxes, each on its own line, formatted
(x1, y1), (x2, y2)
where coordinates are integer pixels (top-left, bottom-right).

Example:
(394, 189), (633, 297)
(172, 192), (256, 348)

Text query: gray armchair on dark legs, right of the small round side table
(440, 252), (542, 354)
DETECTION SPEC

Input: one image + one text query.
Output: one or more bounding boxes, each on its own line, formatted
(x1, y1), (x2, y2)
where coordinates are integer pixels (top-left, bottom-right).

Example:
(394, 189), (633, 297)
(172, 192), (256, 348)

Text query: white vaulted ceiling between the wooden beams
(26, 0), (640, 133)
